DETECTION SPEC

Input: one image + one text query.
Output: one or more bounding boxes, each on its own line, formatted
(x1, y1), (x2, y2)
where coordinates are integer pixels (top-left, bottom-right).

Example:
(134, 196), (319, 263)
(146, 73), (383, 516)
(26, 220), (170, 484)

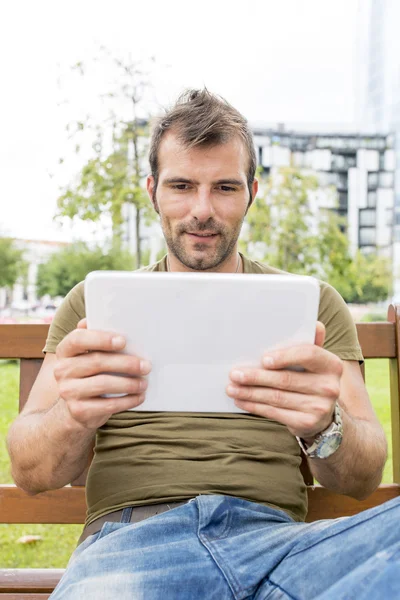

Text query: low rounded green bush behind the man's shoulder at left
(37, 242), (135, 297)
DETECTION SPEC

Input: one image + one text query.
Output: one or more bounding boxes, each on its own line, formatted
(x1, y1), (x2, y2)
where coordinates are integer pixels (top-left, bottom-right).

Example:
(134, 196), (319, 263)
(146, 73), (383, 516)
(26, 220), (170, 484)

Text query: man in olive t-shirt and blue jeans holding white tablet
(8, 90), (400, 600)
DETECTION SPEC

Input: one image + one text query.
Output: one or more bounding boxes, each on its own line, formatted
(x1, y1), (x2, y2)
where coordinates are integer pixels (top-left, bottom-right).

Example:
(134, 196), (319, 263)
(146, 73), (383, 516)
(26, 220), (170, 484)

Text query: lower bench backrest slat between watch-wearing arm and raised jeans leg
(307, 484), (400, 522)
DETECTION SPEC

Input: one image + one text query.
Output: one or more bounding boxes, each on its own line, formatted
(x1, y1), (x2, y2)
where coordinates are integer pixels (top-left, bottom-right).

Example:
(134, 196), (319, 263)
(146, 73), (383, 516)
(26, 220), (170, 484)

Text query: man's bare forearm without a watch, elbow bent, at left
(7, 400), (95, 494)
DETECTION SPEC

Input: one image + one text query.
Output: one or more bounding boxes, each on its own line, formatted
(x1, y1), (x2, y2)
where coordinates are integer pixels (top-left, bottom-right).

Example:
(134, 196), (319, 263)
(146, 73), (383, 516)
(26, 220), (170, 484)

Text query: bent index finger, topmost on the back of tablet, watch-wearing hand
(262, 344), (343, 377)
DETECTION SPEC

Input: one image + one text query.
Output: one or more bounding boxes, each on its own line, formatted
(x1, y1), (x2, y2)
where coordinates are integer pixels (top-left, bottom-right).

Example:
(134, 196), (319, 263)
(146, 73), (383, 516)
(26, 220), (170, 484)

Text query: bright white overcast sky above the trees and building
(0, 0), (358, 241)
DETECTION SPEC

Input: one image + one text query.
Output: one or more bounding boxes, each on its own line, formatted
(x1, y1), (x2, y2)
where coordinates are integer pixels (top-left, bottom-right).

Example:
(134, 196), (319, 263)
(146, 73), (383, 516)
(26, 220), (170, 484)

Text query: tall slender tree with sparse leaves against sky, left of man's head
(57, 51), (156, 266)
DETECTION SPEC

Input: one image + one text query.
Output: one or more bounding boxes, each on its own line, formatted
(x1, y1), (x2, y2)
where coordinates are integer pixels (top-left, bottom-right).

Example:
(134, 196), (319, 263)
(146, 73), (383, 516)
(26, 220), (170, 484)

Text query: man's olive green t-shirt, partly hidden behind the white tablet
(44, 257), (363, 524)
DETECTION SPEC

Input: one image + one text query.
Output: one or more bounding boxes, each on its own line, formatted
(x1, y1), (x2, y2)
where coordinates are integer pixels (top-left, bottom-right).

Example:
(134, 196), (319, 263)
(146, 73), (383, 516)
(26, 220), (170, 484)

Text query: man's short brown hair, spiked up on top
(149, 88), (257, 199)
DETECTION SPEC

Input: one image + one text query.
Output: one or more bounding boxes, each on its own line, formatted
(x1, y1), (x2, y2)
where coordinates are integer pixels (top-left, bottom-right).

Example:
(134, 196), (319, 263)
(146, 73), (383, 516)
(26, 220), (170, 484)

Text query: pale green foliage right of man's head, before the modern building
(240, 167), (391, 303)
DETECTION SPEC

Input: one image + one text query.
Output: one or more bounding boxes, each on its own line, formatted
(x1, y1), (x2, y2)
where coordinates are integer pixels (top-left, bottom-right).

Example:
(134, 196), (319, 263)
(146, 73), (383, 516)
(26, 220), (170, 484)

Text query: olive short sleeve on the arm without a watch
(43, 281), (86, 353)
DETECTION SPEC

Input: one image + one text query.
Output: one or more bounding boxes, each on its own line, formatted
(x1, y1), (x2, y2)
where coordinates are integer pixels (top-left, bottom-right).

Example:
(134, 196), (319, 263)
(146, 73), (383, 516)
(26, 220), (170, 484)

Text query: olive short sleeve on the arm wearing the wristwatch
(318, 282), (364, 362)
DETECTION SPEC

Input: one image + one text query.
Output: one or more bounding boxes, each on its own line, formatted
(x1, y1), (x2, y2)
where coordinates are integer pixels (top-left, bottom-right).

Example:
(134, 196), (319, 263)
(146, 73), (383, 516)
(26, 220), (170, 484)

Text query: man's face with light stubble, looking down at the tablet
(147, 132), (257, 271)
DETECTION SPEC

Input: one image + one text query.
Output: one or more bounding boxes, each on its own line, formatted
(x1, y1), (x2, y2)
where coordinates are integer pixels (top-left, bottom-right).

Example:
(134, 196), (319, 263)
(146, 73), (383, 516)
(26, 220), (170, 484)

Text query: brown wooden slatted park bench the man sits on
(0, 306), (400, 600)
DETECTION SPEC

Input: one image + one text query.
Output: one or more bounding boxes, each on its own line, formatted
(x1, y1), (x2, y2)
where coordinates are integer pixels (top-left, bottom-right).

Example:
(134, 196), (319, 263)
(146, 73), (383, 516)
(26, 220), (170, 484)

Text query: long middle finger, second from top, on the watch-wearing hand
(230, 367), (340, 400)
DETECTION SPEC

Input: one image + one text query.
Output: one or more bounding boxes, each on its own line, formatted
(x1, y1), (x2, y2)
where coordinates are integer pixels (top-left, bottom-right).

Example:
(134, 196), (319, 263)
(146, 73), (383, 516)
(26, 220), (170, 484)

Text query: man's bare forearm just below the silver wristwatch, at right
(309, 408), (387, 500)
